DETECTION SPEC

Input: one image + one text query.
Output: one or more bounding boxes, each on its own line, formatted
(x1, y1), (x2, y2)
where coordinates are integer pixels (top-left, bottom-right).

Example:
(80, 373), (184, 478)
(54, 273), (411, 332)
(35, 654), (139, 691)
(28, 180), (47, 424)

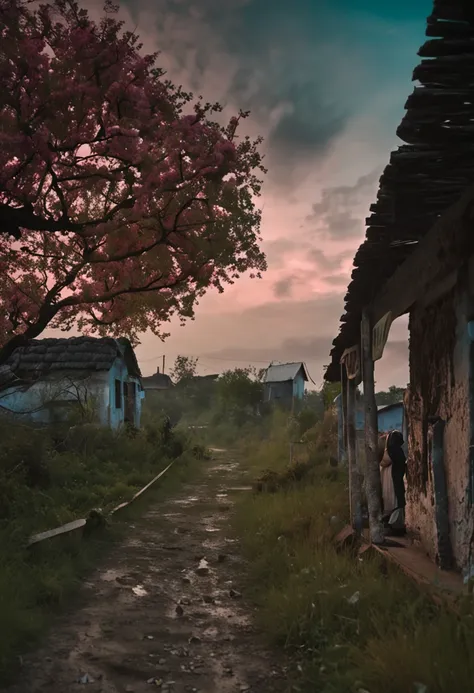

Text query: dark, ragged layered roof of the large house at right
(325, 0), (474, 381)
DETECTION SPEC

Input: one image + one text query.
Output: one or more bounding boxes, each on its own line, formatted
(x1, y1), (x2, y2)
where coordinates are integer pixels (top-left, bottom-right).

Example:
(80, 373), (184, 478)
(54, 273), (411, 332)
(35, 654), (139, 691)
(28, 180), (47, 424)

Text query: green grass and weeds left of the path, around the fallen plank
(0, 410), (206, 683)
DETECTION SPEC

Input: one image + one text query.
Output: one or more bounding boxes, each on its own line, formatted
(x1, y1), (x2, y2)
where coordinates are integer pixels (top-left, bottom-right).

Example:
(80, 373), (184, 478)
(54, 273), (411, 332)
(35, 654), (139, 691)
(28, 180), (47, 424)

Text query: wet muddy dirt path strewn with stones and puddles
(9, 451), (286, 693)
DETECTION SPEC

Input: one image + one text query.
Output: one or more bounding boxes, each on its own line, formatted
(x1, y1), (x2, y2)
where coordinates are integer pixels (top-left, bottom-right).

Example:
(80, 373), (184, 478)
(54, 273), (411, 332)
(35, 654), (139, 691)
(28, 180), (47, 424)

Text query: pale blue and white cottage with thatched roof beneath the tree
(0, 337), (144, 429)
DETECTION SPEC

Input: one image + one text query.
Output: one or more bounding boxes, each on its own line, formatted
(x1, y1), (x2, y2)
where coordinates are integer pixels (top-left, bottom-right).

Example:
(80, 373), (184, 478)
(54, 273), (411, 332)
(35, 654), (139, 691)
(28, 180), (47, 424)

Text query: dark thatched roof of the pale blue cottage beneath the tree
(0, 337), (141, 387)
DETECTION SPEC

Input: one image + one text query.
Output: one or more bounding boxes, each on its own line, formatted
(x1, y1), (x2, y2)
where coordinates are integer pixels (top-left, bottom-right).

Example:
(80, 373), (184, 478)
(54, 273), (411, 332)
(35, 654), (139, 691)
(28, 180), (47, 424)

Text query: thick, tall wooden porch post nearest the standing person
(361, 310), (385, 544)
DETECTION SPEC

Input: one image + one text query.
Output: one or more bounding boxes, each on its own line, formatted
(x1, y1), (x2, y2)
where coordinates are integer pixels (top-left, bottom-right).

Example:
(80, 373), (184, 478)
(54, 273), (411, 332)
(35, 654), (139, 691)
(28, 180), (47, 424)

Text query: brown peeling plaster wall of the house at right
(406, 281), (472, 569)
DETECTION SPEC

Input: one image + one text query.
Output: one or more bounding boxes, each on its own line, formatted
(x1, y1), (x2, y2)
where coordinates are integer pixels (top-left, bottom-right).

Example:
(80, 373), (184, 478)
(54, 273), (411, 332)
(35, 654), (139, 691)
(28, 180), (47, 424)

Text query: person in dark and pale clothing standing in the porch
(380, 431), (406, 533)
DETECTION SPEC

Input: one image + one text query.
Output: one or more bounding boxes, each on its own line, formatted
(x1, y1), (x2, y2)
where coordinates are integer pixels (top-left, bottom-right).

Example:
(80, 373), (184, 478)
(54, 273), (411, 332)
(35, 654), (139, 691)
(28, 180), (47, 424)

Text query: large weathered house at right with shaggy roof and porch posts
(325, 1), (474, 581)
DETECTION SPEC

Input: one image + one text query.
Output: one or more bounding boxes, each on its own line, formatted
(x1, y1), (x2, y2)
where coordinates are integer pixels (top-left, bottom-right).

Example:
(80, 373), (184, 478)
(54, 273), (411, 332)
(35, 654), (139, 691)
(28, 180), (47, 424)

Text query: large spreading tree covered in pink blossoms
(0, 0), (265, 362)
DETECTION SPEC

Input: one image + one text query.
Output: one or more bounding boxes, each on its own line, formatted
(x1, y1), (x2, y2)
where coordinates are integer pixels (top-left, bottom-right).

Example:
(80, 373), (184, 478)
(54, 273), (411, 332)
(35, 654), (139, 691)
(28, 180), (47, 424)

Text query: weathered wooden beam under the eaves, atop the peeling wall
(372, 186), (474, 321)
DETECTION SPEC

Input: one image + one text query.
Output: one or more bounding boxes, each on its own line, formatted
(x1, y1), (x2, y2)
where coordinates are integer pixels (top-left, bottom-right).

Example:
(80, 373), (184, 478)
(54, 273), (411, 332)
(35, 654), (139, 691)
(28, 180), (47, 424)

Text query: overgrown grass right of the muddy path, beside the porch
(234, 410), (474, 693)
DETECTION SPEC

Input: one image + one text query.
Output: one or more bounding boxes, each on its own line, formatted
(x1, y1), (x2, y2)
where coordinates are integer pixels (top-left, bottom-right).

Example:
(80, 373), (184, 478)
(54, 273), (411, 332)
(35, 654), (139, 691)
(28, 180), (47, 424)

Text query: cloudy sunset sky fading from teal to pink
(50, 0), (432, 389)
